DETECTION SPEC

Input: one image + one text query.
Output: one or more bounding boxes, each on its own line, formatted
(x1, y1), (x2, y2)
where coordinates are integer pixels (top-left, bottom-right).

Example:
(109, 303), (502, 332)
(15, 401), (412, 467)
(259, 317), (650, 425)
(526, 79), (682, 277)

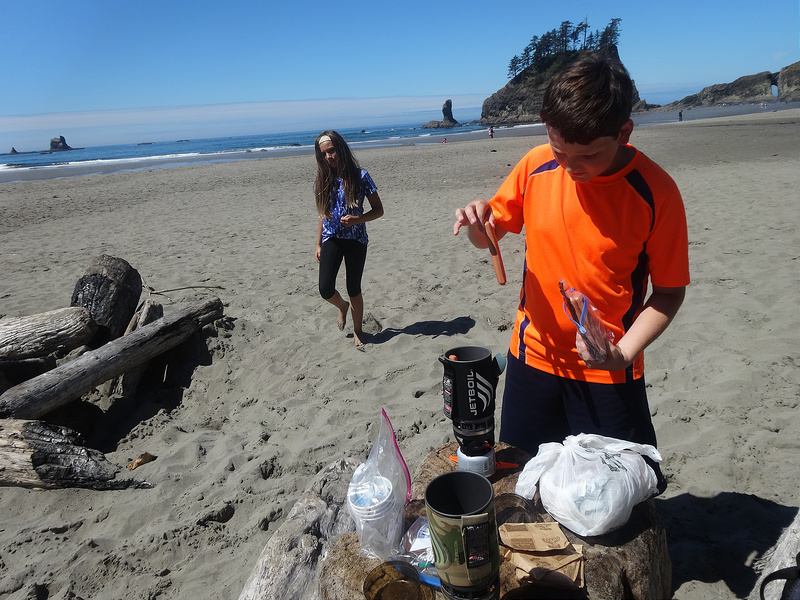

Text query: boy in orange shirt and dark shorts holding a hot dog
(453, 55), (689, 491)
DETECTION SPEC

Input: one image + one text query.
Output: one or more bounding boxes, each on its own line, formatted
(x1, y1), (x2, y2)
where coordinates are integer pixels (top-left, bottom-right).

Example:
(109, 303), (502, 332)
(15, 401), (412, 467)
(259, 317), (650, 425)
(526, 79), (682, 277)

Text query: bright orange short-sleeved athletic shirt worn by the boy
(490, 144), (689, 383)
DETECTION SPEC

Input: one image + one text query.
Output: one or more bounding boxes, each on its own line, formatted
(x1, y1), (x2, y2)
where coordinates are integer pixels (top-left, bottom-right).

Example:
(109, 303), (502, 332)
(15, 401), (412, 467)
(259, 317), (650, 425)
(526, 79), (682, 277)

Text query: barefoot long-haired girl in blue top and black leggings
(314, 131), (383, 347)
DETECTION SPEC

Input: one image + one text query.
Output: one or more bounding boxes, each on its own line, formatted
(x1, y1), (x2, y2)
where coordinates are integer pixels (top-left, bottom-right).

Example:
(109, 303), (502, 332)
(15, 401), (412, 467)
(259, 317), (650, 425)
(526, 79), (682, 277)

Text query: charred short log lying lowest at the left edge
(0, 419), (152, 490)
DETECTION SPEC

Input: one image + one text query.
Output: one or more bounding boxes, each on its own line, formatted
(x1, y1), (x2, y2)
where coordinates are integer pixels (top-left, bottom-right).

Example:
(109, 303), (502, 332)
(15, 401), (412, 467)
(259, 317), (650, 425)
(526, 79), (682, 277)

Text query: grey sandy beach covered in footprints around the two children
(0, 109), (800, 600)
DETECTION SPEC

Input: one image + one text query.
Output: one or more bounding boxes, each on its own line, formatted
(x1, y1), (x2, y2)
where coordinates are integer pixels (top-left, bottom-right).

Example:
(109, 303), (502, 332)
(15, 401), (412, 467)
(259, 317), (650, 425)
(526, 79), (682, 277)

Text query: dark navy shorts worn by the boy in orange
(499, 352), (666, 487)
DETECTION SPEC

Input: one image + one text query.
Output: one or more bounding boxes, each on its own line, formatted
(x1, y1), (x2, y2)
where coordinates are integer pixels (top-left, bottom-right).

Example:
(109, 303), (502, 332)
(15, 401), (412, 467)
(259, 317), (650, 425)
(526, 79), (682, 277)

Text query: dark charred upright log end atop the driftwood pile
(70, 254), (142, 348)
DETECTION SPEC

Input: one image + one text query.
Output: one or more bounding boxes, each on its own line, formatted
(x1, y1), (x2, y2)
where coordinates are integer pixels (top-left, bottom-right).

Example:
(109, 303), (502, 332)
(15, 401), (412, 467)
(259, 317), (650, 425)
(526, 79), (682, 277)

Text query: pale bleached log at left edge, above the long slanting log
(0, 306), (97, 360)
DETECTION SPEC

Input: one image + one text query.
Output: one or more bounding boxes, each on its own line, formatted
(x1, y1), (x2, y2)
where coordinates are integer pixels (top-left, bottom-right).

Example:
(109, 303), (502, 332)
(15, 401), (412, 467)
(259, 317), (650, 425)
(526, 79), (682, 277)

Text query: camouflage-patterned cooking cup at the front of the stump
(425, 471), (500, 600)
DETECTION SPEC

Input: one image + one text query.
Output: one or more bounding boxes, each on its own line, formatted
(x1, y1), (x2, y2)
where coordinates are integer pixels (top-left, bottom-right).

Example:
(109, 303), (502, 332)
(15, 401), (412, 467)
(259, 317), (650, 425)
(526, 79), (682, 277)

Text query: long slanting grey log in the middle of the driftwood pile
(0, 298), (223, 419)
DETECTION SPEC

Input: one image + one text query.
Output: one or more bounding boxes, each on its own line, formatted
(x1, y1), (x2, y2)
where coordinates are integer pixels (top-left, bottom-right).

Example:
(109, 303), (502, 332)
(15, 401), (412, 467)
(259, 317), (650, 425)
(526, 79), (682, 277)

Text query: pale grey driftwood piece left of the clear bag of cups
(239, 459), (360, 600)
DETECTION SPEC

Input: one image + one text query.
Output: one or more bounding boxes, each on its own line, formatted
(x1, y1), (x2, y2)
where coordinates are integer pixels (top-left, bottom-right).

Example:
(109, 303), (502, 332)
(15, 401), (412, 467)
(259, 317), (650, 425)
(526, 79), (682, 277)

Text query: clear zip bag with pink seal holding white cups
(347, 409), (411, 560)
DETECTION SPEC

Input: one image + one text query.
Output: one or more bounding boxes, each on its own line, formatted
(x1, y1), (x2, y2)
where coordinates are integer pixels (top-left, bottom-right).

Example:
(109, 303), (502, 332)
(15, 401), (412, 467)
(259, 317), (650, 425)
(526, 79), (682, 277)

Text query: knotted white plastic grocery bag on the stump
(516, 433), (661, 536)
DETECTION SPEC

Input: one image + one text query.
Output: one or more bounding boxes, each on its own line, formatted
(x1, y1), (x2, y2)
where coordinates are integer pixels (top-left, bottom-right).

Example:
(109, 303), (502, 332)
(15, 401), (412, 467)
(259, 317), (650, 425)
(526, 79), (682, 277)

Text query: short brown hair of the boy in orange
(539, 53), (633, 144)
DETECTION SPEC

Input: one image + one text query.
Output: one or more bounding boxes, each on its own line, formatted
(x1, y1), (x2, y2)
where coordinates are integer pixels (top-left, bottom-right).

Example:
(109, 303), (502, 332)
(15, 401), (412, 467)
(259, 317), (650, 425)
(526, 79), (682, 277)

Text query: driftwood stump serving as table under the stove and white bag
(320, 442), (672, 600)
